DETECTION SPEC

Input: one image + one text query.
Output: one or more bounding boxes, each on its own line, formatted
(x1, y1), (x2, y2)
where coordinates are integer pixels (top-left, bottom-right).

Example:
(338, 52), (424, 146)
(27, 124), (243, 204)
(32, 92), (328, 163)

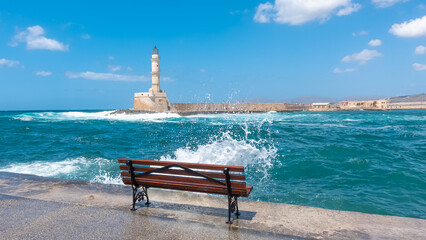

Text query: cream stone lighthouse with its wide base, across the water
(133, 46), (170, 112)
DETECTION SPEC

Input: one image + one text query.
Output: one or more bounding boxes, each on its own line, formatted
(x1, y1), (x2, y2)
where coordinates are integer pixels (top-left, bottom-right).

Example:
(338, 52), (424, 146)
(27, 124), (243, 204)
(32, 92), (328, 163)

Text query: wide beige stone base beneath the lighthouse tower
(133, 89), (171, 112)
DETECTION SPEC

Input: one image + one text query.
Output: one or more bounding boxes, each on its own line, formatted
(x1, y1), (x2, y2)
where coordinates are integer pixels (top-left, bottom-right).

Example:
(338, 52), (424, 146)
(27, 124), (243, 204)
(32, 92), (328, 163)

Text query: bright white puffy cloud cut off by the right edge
(389, 16), (426, 38)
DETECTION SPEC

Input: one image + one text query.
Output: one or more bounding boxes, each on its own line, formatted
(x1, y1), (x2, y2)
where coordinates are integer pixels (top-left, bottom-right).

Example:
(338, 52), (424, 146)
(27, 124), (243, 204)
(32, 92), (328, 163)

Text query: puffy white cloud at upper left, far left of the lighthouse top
(9, 25), (69, 51)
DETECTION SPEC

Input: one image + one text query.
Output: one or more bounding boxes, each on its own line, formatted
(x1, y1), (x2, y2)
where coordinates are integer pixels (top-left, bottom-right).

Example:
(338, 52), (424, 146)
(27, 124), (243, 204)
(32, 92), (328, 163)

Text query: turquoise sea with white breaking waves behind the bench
(0, 110), (426, 219)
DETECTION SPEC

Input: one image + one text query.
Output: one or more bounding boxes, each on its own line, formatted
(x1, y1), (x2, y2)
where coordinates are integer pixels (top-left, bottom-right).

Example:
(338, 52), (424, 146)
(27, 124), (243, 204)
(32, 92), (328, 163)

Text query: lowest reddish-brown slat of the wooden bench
(123, 178), (252, 197)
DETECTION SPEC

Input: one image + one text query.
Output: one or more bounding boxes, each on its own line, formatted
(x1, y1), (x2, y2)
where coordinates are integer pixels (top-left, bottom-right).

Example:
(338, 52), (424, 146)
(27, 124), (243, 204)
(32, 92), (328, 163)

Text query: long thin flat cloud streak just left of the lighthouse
(65, 72), (149, 82)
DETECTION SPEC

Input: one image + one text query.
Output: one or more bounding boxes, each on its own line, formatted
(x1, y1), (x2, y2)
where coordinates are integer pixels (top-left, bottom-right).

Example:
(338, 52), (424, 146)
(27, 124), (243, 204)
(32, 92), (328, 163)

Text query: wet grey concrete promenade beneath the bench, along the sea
(0, 172), (426, 239)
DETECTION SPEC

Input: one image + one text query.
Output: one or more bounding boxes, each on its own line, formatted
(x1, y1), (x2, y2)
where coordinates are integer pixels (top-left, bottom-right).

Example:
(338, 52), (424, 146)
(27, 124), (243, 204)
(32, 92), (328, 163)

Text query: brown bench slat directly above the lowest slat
(121, 172), (246, 188)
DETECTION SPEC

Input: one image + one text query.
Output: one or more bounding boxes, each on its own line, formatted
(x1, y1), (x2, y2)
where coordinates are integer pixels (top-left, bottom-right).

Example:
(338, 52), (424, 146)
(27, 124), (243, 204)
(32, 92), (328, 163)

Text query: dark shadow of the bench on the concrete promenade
(137, 201), (256, 220)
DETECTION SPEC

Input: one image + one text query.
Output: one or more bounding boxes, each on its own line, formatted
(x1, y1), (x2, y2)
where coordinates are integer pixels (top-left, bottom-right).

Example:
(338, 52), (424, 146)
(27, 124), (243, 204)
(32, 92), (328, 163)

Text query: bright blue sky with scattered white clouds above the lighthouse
(0, 0), (426, 110)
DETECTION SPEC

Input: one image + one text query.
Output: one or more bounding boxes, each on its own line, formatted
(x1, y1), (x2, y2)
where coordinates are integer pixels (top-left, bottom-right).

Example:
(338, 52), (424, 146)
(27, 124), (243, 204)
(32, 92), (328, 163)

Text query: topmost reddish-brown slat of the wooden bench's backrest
(118, 158), (244, 172)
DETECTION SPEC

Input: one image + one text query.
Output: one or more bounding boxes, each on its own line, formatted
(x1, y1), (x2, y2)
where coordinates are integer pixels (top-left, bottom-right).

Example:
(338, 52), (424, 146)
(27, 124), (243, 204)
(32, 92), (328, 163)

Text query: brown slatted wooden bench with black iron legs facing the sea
(118, 158), (253, 224)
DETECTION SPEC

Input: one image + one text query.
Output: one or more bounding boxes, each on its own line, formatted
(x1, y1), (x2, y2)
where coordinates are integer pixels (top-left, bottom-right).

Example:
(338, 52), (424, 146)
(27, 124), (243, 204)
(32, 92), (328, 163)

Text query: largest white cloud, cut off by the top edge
(254, 0), (361, 25)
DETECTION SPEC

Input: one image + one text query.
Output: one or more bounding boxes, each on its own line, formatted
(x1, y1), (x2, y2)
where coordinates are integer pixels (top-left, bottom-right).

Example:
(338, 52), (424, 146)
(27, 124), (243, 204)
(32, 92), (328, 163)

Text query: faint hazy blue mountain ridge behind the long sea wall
(238, 96), (387, 104)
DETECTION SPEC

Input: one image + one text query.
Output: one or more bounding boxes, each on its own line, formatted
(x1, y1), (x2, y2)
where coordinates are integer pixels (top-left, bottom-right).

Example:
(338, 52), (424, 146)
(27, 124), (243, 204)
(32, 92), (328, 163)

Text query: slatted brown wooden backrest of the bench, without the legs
(118, 158), (247, 196)
